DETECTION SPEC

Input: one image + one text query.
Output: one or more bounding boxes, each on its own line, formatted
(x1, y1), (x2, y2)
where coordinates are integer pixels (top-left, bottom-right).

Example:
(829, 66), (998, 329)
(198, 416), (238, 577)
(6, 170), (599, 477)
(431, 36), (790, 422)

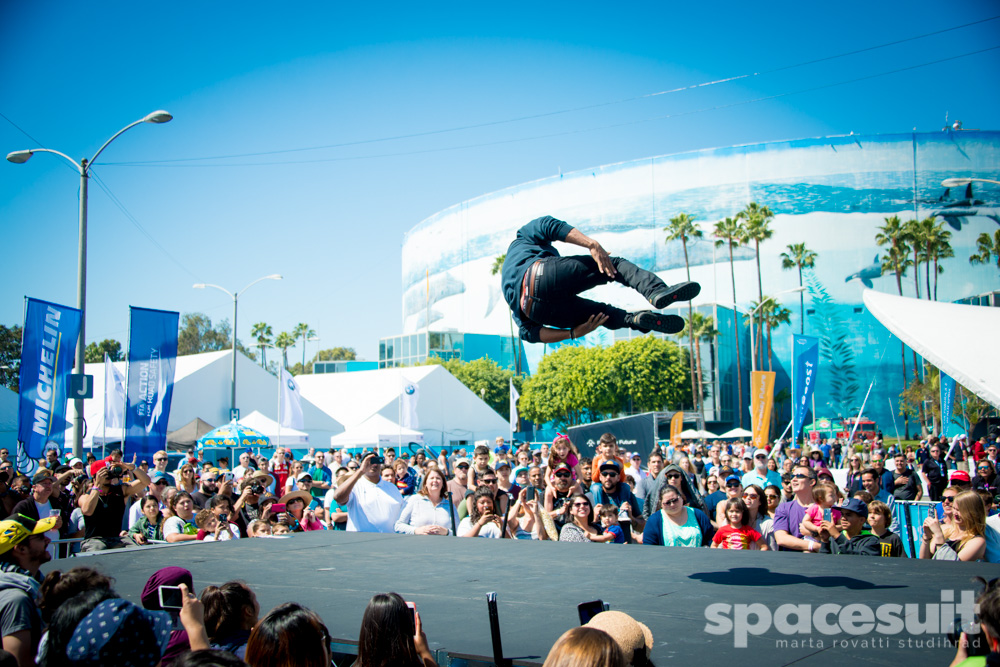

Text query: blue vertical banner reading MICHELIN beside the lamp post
(17, 299), (83, 459)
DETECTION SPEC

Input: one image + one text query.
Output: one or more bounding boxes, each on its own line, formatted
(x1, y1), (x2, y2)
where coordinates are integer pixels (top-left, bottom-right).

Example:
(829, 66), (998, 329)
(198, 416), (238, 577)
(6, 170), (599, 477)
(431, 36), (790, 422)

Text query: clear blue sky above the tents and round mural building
(0, 0), (1000, 361)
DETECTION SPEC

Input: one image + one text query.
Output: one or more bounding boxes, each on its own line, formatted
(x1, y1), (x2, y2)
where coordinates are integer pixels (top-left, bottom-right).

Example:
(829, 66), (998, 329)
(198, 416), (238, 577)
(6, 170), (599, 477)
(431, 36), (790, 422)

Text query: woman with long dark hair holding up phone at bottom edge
(358, 593), (437, 667)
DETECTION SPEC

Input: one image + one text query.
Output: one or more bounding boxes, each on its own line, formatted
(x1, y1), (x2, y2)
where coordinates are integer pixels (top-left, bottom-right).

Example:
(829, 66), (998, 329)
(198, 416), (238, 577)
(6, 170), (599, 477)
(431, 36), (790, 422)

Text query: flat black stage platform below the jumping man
(43, 531), (1000, 666)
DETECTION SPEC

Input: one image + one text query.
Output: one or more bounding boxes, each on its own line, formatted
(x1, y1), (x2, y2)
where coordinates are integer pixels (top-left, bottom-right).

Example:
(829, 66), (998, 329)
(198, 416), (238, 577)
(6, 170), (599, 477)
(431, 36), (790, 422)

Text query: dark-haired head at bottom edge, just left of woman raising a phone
(244, 602), (331, 667)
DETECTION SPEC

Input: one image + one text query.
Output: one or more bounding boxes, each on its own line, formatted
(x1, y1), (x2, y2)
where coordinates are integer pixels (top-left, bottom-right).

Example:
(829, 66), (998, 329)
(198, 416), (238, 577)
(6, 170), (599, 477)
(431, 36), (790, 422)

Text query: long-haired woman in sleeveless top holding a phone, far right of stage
(920, 491), (986, 561)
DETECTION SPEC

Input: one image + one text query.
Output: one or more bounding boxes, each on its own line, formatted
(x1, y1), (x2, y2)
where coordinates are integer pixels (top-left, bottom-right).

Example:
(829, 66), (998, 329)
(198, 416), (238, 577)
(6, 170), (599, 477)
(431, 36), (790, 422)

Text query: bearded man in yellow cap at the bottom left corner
(0, 517), (57, 665)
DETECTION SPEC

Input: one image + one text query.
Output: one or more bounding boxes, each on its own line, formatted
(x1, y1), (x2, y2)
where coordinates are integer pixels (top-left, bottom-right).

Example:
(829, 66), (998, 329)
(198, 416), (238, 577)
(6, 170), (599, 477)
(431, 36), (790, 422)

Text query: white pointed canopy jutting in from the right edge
(863, 290), (1000, 408)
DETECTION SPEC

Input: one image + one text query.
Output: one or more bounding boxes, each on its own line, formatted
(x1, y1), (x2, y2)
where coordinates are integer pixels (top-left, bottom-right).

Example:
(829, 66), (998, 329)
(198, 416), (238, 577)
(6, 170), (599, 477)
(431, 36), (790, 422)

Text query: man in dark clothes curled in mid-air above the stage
(503, 216), (701, 343)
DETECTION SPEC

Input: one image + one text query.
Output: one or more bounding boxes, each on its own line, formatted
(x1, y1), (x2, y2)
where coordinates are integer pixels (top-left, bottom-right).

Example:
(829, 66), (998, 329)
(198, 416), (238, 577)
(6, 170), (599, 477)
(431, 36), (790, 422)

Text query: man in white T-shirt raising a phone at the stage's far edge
(333, 451), (403, 533)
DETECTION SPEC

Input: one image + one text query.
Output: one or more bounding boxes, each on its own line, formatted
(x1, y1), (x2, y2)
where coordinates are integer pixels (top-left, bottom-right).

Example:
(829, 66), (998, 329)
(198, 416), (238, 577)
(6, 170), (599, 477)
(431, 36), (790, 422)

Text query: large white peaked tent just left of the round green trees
(295, 365), (510, 447)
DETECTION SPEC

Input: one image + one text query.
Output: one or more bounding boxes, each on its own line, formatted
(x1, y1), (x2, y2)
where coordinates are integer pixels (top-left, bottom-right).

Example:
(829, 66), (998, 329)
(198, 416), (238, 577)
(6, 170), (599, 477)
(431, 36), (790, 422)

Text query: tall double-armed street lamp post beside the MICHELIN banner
(7, 110), (173, 458)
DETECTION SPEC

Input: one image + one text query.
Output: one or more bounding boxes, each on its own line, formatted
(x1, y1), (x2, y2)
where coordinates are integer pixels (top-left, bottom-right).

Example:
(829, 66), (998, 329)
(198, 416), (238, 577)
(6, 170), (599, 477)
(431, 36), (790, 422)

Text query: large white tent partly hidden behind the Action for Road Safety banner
(67, 350), (344, 447)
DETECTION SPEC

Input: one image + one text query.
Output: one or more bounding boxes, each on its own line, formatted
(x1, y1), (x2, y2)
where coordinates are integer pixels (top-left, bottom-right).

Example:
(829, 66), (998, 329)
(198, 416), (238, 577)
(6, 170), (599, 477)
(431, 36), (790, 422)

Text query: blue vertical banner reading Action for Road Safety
(122, 306), (180, 461)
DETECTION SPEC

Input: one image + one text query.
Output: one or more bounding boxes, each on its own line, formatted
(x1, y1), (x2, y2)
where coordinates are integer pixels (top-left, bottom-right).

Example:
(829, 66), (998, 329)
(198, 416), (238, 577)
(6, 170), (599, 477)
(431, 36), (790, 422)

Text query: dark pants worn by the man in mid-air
(531, 255), (666, 329)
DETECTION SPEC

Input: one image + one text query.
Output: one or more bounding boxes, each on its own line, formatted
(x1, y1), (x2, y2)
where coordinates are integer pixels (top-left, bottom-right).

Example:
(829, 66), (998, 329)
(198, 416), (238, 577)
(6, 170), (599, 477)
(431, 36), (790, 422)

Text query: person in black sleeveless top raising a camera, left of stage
(80, 457), (149, 552)
